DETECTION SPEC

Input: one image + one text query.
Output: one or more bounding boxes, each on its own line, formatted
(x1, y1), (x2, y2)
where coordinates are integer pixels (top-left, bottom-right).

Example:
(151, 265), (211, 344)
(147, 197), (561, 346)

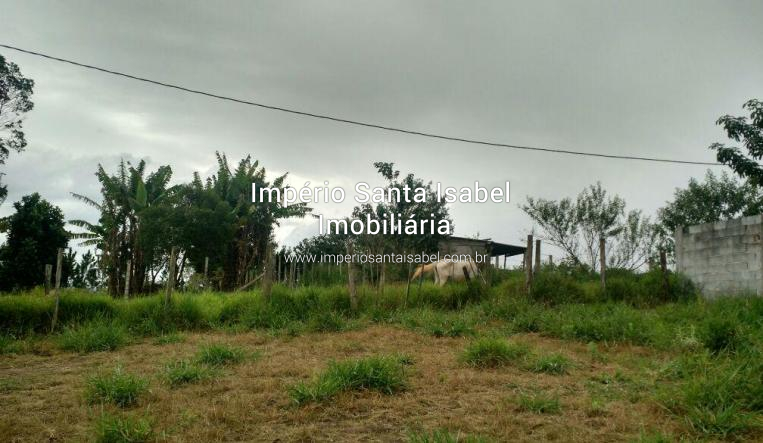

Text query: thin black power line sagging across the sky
(0, 43), (722, 166)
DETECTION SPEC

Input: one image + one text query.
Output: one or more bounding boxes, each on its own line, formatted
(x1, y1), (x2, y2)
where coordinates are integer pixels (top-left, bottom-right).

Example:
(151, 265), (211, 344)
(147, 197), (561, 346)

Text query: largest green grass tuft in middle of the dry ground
(289, 356), (407, 405)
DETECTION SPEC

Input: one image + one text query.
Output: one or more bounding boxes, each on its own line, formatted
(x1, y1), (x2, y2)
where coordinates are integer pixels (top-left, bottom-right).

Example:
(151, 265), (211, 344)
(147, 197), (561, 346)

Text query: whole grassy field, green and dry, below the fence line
(0, 278), (763, 442)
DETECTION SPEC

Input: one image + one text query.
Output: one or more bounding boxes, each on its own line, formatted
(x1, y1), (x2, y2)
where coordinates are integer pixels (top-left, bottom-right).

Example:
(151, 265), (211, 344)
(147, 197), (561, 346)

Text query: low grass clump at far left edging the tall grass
(59, 320), (128, 353)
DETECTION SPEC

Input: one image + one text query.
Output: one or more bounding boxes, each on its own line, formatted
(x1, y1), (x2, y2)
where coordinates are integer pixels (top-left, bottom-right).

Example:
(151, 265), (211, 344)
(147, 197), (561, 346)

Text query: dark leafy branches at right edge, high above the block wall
(710, 99), (763, 187)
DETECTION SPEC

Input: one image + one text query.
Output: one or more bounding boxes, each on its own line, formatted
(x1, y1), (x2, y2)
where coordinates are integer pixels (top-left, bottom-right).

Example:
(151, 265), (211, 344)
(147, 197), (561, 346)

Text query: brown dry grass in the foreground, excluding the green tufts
(0, 326), (680, 442)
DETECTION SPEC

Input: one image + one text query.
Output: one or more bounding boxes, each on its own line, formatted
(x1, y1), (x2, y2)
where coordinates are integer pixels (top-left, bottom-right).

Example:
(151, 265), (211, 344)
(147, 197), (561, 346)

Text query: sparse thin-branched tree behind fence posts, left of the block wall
(521, 183), (656, 270)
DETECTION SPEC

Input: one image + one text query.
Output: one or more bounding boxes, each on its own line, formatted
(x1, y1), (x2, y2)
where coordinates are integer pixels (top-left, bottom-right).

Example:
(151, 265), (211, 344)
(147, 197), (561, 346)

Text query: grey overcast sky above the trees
(0, 0), (763, 262)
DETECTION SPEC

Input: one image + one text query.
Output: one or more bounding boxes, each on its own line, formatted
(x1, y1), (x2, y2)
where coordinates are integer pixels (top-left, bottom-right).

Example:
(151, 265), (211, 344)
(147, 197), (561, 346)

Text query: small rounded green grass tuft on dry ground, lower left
(85, 366), (148, 408)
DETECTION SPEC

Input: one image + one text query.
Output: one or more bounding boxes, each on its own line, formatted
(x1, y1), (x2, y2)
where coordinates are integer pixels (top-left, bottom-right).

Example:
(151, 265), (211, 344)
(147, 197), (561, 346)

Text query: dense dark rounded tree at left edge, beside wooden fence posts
(0, 193), (69, 291)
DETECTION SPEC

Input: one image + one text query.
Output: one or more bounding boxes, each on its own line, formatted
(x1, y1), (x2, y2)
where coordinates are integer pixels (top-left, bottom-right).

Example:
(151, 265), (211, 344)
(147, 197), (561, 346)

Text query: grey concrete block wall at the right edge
(675, 215), (763, 298)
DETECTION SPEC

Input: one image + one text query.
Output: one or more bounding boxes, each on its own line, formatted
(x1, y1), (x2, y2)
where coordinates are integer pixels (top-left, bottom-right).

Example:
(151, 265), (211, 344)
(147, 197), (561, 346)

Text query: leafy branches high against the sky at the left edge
(0, 55), (34, 203)
